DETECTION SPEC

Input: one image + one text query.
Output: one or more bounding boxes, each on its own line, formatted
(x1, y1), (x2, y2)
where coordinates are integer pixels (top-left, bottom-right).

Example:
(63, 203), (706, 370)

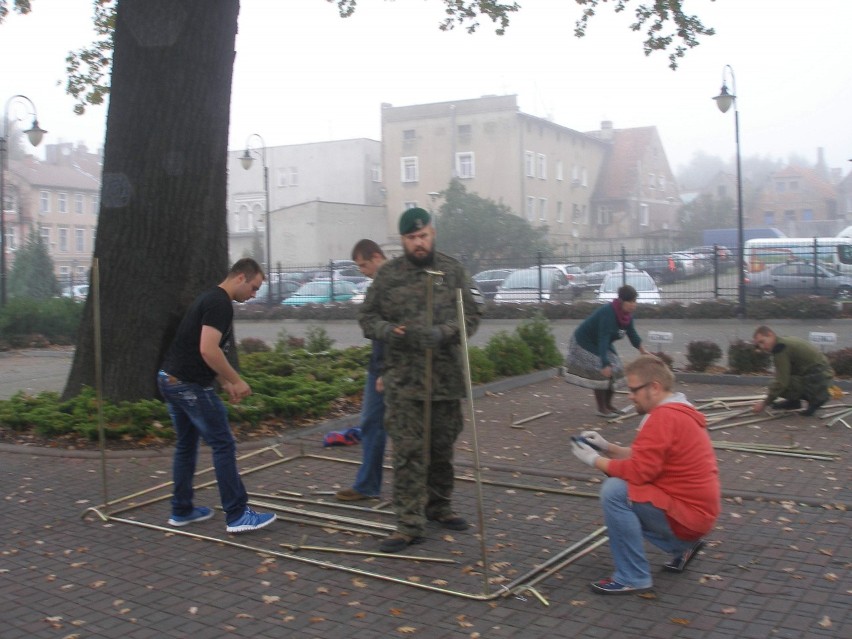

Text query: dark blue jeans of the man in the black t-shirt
(157, 371), (248, 523)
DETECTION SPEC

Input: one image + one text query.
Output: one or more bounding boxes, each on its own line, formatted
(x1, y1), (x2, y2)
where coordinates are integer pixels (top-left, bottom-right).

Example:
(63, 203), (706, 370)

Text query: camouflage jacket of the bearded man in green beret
(358, 252), (485, 401)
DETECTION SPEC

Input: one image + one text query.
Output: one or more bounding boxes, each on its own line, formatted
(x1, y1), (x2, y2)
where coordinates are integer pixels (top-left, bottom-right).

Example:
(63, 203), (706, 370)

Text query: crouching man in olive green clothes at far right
(752, 326), (834, 416)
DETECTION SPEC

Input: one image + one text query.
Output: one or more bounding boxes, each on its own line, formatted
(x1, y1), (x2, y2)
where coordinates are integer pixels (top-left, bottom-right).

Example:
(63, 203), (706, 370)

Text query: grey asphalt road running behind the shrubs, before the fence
(0, 319), (852, 399)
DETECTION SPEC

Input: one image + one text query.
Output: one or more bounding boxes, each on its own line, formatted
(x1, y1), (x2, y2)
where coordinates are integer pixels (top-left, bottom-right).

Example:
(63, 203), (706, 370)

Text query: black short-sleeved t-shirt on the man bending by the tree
(162, 286), (234, 386)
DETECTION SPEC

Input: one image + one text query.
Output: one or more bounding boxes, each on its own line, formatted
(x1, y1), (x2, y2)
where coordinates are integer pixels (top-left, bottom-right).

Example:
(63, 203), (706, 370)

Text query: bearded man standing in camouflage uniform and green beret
(359, 208), (484, 552)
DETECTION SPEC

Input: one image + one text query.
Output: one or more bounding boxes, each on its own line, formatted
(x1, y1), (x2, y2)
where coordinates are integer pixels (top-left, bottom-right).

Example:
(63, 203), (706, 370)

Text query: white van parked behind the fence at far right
(743, 237), (852, 275)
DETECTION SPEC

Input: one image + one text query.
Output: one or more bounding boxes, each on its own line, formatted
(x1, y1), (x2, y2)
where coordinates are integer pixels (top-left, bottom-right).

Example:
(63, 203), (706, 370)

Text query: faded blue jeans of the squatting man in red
(600, 477), (694, 588)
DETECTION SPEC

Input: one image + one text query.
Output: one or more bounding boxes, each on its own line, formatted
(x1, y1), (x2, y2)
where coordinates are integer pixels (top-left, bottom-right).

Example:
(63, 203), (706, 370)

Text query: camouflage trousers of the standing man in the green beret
(385, 398), (464, 537)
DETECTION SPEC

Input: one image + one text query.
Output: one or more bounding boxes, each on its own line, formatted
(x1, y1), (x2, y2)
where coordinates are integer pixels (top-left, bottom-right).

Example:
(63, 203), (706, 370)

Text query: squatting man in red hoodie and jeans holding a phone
(572, 355), (721, 595)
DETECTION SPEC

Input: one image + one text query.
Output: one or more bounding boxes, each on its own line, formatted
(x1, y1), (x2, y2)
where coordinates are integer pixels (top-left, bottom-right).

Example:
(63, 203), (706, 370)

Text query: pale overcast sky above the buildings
(0, 0), (852, 175)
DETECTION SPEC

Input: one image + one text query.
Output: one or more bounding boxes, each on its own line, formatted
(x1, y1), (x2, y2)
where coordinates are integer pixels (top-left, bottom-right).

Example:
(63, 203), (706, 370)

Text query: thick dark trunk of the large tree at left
(64, 0), (239, 401)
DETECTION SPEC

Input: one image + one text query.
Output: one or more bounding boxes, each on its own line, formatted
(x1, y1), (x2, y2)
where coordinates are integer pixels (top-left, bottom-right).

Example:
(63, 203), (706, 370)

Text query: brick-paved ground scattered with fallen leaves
(0, 377), (852, 639)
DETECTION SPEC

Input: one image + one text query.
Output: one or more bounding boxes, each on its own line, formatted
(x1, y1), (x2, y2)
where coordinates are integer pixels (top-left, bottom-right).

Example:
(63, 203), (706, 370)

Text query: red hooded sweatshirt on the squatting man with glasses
(607, 393), (721, 540)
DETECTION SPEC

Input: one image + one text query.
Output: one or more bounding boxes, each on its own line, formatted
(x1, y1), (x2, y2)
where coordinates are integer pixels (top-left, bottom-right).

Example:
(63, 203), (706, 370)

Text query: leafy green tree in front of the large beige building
(436, 180), (553, 271)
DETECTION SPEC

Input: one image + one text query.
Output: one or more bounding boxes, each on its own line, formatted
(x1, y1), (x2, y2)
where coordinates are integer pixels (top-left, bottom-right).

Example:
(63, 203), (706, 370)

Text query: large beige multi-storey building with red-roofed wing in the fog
(382, 95), (679, 255)
